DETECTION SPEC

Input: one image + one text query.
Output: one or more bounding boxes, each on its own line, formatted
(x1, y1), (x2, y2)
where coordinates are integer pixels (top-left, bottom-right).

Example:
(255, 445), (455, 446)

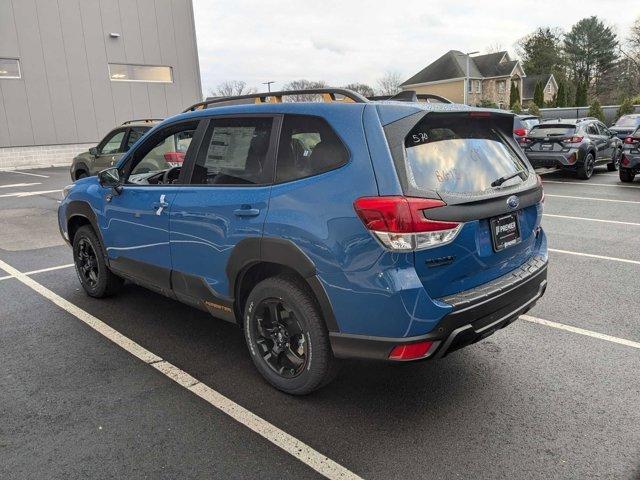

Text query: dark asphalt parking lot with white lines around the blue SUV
(0, 168), (640, 479)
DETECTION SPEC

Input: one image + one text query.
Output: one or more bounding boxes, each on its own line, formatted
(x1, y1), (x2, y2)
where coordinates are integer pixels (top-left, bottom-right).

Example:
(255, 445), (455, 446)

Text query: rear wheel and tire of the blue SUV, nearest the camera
(243, 276), (337, 395)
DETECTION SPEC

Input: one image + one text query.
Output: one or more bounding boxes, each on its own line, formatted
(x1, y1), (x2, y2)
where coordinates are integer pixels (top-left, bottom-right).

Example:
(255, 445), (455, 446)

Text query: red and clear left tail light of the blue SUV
(353, 196), (462, 252)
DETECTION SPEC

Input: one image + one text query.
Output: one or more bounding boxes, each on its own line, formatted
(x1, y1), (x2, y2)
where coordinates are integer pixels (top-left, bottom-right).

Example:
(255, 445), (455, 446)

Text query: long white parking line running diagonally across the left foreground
(0, 260), (360, 480)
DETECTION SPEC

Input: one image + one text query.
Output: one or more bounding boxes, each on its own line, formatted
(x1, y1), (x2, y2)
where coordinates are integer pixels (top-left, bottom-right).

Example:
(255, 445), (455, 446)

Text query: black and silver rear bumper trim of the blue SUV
(330, 257), (547, 360)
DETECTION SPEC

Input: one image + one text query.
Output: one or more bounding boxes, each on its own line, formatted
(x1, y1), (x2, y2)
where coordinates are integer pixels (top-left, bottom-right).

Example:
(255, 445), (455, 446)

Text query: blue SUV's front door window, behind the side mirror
(129, 122), (198, 178)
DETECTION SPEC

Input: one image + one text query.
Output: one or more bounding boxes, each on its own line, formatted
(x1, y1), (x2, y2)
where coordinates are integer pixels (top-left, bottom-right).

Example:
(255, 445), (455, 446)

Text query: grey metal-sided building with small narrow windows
(0, 0), (202, 168)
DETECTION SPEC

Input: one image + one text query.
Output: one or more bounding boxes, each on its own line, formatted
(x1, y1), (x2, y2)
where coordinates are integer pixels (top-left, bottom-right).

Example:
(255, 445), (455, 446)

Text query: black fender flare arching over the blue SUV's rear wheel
(226, 237), (340, 332)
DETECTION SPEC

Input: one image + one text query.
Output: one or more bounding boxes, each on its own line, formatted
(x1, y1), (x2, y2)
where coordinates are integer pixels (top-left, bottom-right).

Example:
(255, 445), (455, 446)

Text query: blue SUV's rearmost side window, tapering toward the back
(276, 115), (349, 183)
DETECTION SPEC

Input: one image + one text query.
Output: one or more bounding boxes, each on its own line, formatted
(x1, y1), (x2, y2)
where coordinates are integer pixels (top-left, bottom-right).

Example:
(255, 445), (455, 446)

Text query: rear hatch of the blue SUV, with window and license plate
(390, 111), (542, 298)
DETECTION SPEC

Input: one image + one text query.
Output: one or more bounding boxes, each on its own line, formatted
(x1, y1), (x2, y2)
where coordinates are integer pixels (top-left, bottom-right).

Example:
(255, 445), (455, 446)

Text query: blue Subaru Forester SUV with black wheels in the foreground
(58, 89), (547, 394)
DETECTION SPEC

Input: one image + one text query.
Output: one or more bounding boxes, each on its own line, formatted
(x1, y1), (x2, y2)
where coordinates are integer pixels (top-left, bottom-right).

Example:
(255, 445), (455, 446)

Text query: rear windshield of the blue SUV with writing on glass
(404, 115), (528, 195)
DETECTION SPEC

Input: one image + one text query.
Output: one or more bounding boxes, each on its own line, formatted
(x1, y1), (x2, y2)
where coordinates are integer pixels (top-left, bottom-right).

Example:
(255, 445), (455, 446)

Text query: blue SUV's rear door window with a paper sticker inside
(191, 117), (273, 185)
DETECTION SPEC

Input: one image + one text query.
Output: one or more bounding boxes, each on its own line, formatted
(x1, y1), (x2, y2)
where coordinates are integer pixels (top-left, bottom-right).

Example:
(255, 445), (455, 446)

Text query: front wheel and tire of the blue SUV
(73, 225), (124, 298)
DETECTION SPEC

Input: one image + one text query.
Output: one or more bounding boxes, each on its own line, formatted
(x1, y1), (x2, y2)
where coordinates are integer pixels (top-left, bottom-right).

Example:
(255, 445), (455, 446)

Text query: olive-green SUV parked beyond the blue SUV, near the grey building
(70, 118), (162, 181)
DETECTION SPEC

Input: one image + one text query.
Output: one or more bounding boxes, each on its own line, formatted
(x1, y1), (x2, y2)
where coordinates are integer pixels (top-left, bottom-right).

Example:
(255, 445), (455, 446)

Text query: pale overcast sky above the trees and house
(193, 0), (640, 95)
